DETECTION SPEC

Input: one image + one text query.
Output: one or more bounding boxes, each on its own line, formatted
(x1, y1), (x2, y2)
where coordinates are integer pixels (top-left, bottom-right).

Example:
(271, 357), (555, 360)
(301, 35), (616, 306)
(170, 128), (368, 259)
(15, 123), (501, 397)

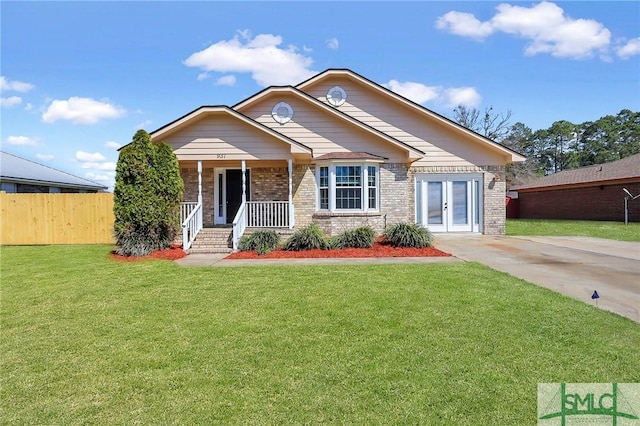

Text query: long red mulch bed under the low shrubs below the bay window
(226, 242), (451, 259)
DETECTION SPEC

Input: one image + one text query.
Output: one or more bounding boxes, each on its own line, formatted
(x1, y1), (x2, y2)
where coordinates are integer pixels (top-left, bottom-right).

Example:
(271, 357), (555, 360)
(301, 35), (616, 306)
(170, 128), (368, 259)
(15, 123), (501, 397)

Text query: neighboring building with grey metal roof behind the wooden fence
(0, 151), (107, 193)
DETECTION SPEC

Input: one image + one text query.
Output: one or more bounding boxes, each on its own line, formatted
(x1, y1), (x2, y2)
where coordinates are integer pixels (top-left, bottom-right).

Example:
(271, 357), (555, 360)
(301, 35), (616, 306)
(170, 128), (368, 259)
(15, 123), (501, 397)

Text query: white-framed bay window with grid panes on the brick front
(317, 164), (379, 211)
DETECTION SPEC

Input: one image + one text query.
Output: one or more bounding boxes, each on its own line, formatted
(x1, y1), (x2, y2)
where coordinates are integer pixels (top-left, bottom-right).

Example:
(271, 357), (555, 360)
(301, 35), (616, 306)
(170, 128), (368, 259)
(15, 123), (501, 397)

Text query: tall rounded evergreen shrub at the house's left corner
(113, 130), (184, 256)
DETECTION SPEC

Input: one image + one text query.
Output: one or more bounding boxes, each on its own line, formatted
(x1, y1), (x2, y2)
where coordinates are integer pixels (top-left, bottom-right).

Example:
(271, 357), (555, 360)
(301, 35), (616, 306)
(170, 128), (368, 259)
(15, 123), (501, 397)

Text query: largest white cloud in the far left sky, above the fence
(42, 96), (126, 124)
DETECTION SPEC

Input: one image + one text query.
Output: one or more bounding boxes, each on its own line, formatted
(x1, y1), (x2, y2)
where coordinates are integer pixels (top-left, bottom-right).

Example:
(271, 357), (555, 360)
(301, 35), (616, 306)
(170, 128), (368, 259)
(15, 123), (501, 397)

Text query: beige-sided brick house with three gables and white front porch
(150, 69), (524, 248)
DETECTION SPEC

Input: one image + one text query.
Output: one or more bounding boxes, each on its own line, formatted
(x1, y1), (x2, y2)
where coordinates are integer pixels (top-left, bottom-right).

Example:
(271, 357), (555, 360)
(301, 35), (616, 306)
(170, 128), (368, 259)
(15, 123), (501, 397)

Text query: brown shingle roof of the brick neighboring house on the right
(512, 154), (640, 191)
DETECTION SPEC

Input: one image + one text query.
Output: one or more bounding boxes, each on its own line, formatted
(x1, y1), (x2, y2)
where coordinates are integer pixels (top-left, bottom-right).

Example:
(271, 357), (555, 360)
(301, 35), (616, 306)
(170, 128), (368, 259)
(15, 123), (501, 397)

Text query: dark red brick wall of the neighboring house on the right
(518, 182), (640, 222)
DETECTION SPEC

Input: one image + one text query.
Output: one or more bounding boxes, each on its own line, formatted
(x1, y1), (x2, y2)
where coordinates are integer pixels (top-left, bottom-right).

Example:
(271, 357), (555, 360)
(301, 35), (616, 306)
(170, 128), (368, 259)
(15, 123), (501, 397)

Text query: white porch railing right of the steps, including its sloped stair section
(233, 201), (294, 250)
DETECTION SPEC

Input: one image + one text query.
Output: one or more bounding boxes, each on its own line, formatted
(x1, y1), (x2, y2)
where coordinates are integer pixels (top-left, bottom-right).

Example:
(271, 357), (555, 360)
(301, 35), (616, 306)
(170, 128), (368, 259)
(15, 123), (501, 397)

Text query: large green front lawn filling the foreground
(0, 246), (640, 425)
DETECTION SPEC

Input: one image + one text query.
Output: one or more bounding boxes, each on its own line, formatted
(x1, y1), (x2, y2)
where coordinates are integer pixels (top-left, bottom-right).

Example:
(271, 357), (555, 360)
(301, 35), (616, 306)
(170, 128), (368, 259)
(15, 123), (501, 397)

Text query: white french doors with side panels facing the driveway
(416, 174), (482, 232)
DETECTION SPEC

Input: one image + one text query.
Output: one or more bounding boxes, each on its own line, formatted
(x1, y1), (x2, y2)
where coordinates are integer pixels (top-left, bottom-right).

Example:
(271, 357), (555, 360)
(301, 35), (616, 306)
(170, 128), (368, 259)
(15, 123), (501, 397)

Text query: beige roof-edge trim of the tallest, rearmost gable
(296, 69), (525, 161)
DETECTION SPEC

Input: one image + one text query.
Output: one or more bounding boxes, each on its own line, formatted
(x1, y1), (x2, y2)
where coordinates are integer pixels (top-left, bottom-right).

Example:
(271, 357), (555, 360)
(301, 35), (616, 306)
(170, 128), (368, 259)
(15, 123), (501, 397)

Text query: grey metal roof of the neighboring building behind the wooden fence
(0, 151), (107, 190)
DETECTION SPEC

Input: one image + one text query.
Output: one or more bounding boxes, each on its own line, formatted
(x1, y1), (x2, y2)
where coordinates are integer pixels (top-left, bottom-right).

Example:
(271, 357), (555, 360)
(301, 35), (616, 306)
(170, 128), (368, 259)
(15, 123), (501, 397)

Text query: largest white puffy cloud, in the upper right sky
(436, 1), (611, 59)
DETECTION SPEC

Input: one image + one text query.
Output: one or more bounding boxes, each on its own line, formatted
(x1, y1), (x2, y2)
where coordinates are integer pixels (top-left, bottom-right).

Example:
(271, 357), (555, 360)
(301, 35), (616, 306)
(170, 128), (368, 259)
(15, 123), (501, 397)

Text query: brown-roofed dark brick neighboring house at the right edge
(510, 154), (640, 222)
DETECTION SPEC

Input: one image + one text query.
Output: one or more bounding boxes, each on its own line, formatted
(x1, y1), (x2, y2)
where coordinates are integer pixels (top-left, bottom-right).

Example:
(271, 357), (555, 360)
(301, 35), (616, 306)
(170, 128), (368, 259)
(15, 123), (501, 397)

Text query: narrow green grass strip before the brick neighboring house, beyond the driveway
(506, 219), (640, 241)
